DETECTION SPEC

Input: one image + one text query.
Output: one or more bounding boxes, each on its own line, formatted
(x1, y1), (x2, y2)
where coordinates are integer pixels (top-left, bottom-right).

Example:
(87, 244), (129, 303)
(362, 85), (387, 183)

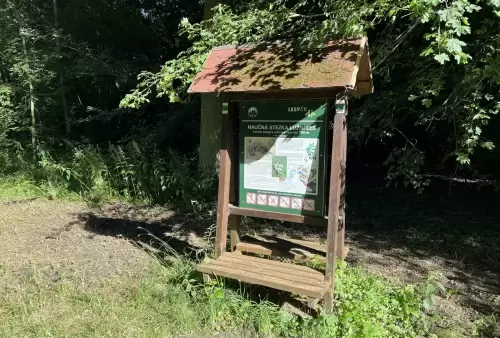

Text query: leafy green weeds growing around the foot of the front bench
(164, 263), (442, 337)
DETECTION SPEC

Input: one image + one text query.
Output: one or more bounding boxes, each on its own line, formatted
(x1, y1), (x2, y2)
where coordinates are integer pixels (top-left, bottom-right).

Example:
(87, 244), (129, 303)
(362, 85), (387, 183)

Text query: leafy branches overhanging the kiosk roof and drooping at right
(121, 0), (500, 187)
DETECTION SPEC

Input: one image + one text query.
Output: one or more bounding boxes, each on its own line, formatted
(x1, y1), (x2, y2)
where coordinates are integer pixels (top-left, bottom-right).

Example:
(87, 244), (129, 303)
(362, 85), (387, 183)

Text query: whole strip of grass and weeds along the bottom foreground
(0, 252), (446, 337)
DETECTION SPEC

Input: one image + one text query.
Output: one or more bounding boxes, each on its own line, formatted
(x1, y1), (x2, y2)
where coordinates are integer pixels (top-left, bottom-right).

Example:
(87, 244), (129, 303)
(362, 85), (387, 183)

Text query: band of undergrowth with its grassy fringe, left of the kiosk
(0, 142), (215, 205)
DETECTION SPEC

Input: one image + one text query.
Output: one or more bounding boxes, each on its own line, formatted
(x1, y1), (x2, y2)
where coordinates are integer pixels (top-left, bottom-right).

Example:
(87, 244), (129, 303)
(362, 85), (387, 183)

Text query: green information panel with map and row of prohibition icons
(239, 100), (327, 217)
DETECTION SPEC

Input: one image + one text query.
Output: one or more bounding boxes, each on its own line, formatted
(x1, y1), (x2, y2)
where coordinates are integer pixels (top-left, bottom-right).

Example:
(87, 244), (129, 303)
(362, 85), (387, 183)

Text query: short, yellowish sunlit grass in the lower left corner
(0, 264), (200, 337)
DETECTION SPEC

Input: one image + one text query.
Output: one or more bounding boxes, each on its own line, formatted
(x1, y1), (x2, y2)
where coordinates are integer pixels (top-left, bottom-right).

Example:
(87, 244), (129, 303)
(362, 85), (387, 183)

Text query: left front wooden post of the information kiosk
(215, 103), (234, 258)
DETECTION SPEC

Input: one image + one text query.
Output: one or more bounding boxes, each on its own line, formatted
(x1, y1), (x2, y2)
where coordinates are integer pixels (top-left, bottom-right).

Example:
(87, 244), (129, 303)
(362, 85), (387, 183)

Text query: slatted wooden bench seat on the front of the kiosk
(197, 251), (329, 301)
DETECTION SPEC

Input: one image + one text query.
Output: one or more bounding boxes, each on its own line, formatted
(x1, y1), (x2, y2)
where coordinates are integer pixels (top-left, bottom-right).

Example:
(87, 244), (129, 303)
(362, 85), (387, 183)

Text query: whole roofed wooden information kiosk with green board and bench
(189, 38), (373, 313)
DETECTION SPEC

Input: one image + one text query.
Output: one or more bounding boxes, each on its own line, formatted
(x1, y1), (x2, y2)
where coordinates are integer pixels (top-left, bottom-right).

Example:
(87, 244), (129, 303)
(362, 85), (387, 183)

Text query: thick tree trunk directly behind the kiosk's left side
(199, 0), (222, 174)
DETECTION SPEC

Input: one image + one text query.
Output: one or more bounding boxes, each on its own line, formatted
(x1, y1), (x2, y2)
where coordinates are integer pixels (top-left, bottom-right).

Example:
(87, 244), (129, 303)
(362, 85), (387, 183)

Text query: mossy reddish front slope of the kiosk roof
(190, 39), (361, 92)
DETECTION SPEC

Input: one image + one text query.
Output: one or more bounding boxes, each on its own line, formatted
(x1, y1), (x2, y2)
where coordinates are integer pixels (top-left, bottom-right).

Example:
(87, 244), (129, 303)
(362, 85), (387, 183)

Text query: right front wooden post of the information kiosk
(324, 101), (345, 313)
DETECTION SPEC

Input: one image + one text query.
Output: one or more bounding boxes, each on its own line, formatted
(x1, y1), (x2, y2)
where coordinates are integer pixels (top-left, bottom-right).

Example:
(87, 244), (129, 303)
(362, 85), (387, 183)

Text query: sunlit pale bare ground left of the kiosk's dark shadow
(0, 199), (149, 284)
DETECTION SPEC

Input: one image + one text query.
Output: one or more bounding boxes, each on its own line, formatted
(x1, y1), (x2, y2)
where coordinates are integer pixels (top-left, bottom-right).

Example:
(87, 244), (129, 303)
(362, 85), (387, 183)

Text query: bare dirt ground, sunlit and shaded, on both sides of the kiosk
(0, 187), (500, 336)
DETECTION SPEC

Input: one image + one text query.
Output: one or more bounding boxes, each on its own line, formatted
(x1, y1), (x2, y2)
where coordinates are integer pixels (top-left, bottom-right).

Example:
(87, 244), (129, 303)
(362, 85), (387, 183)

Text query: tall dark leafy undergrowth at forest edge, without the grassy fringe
(30, 142), (214, 204)
